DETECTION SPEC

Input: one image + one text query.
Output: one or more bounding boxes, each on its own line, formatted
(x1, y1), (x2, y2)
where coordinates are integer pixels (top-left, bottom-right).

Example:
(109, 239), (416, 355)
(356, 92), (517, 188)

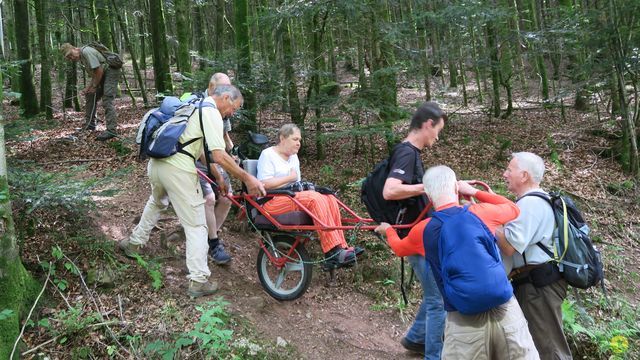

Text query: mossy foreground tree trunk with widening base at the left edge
(0, 68), (34, 359)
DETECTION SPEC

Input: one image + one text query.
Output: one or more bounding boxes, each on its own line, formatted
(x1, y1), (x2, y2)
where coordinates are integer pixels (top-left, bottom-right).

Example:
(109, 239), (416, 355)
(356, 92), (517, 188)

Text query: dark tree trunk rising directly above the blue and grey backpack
(149, 0), (173, 94)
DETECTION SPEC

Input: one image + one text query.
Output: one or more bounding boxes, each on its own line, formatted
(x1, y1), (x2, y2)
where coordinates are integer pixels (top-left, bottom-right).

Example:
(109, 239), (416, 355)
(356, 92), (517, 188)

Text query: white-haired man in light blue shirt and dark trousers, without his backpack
(496, 152), (572, 360)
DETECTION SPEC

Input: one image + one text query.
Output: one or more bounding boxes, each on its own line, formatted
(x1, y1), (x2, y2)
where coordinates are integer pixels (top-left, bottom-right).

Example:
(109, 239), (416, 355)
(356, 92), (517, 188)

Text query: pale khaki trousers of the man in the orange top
(442, 297), (540, 360)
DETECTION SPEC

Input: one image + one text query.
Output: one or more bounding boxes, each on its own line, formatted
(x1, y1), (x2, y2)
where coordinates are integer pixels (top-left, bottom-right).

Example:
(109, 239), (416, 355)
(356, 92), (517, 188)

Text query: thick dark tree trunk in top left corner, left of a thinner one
(13, 0), (39, 117)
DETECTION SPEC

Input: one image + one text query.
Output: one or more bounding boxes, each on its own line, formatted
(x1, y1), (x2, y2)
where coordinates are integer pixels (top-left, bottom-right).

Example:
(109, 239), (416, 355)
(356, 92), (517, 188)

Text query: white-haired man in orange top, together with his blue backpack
(375, 165), (538, 360)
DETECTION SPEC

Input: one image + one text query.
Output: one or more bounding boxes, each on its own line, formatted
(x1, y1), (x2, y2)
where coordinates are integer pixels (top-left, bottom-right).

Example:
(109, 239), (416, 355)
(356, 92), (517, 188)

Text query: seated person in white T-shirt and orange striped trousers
(258, 124), (364, 269)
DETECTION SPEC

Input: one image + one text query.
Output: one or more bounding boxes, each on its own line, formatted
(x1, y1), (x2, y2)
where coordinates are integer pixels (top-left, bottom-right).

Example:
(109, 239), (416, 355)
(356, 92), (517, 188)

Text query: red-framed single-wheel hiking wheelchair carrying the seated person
(199, 133), (429, 301)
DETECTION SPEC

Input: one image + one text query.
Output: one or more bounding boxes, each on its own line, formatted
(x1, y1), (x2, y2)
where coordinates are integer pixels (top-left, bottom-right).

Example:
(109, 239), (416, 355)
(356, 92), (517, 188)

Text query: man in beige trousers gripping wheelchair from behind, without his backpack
(119, 85), (266, 297)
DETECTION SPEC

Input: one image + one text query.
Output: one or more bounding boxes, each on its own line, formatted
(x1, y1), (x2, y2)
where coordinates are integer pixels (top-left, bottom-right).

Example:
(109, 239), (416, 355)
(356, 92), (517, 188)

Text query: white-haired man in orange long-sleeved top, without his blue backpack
(376, 166), (539, 359)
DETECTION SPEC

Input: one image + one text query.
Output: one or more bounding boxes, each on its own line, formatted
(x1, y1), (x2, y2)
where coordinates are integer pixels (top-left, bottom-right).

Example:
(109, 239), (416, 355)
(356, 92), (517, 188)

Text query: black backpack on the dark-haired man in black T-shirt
(360, 143), (421, 224)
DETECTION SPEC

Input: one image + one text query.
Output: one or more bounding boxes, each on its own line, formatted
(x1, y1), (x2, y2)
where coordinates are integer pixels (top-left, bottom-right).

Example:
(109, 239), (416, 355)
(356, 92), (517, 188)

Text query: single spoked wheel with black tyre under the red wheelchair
(257, 236), (313, 301)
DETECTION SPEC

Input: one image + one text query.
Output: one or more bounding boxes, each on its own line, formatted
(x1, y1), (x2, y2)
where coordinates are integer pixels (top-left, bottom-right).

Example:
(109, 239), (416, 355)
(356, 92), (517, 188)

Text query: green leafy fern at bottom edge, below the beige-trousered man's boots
(143, 298), (233, 360)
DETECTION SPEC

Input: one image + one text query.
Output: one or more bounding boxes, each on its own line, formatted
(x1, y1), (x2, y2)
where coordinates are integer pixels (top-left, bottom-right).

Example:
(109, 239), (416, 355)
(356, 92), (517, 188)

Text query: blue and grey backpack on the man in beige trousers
(136, 96), (215, 160)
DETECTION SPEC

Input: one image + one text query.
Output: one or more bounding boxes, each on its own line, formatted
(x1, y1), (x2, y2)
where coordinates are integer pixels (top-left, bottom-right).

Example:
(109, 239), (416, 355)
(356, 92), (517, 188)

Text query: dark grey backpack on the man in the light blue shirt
(525, 192), (604, 289)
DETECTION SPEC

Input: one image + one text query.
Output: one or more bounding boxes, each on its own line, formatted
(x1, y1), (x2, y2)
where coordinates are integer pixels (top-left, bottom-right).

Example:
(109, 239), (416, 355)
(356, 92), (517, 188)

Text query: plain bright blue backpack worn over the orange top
(425, 206), (513, 315)
